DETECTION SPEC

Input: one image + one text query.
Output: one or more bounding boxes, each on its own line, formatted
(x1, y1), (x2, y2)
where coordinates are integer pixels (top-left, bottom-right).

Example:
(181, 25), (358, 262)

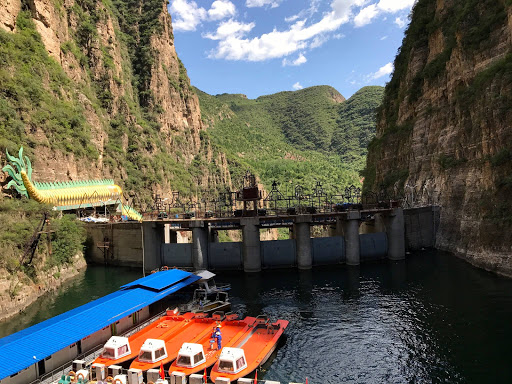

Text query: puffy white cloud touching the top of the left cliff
(169, 0), (236, 31)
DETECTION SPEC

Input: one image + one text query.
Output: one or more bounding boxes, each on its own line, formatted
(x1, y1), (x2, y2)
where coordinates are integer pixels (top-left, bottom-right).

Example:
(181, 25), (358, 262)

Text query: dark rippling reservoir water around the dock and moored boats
(0, 251), (512, 384)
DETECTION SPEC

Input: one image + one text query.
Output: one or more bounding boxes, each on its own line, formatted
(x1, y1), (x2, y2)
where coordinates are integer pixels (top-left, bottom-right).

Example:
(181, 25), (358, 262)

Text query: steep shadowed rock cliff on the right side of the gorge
(365, 0), (512, 276)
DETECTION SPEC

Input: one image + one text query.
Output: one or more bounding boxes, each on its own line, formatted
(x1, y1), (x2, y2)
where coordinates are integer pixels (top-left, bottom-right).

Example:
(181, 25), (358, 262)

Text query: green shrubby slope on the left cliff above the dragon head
(0, 11), (98, 159)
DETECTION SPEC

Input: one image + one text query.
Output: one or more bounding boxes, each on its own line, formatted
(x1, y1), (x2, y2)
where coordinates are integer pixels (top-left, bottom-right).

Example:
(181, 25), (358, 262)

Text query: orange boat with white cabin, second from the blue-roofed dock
(130, 312), (224, 371)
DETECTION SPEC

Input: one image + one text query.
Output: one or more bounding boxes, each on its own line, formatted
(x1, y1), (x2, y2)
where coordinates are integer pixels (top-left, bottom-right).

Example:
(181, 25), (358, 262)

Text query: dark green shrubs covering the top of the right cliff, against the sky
(381, 0), (510, 126)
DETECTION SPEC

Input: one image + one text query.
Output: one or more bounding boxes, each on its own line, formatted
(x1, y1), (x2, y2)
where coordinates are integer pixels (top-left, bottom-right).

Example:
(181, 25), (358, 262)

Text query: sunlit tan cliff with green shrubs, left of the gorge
(0, 0), (231, 202)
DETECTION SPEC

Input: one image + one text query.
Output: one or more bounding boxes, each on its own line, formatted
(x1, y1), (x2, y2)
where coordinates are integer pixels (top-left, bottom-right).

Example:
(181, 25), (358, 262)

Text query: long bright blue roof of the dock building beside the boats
(0, 269), (200, 380)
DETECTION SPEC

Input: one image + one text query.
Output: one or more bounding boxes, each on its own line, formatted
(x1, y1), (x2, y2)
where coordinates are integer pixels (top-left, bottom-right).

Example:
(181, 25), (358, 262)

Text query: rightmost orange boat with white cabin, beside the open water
(210, 316), (288, 383)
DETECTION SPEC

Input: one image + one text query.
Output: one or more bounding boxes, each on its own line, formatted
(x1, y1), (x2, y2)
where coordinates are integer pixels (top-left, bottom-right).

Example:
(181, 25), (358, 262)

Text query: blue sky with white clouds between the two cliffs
(169, 0), (415, 98)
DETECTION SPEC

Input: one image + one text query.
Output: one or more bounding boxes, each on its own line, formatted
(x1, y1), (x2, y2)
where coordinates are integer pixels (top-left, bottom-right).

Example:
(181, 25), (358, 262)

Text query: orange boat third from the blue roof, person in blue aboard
(169, 314), (256, 382)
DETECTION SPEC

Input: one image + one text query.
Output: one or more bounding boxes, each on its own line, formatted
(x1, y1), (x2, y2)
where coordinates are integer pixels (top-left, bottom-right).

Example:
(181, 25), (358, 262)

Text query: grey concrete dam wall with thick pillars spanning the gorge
(87, 206), (439, 271)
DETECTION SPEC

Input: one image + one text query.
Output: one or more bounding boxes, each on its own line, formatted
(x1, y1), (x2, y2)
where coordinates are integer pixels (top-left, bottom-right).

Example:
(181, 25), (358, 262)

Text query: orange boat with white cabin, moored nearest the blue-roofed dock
(93, 311), (195, 367)
